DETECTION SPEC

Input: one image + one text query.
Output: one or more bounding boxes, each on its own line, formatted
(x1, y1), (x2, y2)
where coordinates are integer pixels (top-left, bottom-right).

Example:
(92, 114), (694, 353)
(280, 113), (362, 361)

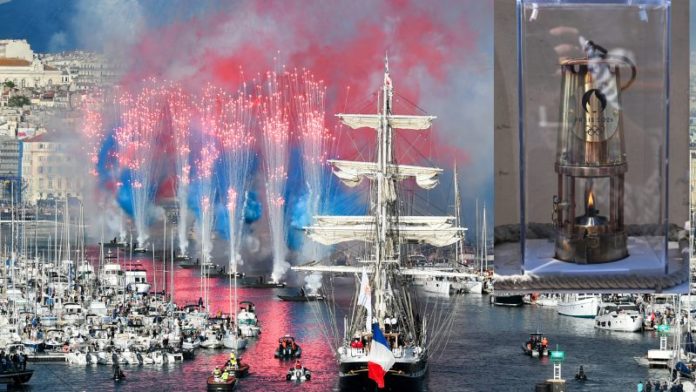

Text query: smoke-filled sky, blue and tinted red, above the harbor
(0, 0), (498, 239)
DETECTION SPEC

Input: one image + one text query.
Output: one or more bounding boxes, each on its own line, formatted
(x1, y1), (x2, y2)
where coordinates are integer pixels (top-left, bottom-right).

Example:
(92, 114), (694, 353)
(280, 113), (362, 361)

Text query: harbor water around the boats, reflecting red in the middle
(12, 262), (667, 392)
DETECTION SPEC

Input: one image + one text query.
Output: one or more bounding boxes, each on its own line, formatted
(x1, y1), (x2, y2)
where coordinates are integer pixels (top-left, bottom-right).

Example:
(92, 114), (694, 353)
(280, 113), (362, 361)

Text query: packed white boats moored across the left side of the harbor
(0, 237), (326, 390)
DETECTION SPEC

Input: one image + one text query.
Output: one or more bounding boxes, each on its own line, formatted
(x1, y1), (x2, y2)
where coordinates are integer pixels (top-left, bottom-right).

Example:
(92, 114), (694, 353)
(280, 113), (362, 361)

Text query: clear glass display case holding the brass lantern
(517, 0), (678, 288)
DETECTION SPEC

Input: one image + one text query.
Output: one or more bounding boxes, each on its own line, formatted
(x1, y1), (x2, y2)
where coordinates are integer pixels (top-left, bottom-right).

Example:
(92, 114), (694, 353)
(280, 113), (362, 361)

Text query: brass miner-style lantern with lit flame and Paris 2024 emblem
(553, 41), (636, 264)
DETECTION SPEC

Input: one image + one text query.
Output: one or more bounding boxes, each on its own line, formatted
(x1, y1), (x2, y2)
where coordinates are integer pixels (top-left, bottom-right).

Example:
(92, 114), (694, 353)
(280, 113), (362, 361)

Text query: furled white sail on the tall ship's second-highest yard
(328, 159), (442, 189)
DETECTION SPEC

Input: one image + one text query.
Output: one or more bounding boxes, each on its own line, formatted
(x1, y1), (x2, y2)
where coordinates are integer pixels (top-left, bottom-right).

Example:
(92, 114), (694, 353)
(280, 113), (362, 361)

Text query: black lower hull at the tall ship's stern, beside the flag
(339, 360), (428, 392)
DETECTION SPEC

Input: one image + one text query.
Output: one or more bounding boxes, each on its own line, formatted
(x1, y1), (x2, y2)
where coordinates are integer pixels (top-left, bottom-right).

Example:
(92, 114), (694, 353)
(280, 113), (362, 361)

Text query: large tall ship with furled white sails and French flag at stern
(293, 59), (465, 391)
